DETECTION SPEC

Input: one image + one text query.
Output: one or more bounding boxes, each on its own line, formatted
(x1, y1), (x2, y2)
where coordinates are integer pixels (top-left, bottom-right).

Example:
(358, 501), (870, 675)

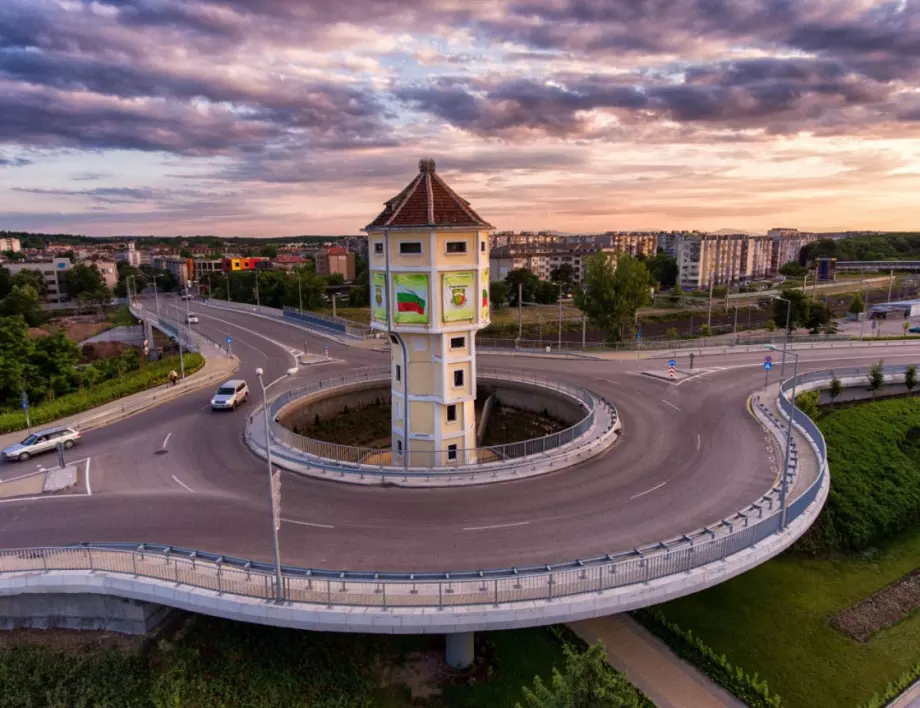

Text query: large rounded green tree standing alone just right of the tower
(575, 253), (651, 338)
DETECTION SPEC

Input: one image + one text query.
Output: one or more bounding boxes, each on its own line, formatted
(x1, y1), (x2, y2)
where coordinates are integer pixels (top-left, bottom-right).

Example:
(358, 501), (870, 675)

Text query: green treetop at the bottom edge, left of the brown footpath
(517, 642), (640, 708)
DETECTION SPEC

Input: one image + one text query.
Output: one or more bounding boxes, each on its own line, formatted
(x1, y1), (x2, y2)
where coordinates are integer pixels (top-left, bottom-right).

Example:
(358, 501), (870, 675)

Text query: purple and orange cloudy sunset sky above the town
(0, 0), (920, 236)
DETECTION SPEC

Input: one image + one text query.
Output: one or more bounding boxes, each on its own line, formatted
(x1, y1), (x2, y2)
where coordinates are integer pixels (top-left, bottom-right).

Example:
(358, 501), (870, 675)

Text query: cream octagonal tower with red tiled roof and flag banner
(364, 160), (492, 465)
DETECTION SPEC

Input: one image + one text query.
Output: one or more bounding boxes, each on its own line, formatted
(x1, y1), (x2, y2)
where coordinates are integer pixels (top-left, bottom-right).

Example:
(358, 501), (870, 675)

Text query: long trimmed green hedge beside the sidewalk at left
(0, 353), (204, 433)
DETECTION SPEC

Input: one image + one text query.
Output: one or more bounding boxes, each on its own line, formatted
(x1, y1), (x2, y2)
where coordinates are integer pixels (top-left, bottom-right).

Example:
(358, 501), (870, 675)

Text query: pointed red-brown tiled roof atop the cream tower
(365, 159), (494, 230)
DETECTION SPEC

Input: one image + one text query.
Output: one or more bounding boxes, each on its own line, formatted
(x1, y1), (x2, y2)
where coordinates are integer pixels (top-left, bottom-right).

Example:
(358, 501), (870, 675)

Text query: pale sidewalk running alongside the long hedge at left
(0, 340), (239, 448)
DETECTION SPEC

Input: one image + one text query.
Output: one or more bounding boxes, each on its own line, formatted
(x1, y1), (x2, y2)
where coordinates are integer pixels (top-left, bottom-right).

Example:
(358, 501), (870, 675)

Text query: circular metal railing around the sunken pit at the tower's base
(269, 368), (604, 475)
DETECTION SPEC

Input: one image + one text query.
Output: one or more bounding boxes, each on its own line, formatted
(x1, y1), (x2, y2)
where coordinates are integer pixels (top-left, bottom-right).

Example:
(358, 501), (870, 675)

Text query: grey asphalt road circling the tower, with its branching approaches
(0, 298), (920, 571)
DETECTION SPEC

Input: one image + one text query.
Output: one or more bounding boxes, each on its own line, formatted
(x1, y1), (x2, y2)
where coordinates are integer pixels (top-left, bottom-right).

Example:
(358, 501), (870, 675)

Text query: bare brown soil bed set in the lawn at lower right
(830, 568), (920, 642)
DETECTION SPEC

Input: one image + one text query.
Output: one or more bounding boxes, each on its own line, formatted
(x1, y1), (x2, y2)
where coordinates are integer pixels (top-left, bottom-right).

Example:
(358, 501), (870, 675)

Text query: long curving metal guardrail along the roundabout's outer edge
(0, 367), (864, 608)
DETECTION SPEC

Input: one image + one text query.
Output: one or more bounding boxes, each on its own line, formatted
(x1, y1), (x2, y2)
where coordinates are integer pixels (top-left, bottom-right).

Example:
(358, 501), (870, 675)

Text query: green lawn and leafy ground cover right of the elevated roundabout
(660, 399), (920, 708)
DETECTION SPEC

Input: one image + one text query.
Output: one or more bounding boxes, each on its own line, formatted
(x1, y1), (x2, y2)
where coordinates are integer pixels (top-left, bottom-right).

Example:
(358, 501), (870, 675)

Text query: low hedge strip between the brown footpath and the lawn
(632, 609), (783, 708)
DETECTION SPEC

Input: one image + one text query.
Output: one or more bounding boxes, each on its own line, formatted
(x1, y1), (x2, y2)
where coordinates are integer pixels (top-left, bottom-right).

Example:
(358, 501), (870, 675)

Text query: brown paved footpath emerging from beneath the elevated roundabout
(569, 614), (744, 708)
